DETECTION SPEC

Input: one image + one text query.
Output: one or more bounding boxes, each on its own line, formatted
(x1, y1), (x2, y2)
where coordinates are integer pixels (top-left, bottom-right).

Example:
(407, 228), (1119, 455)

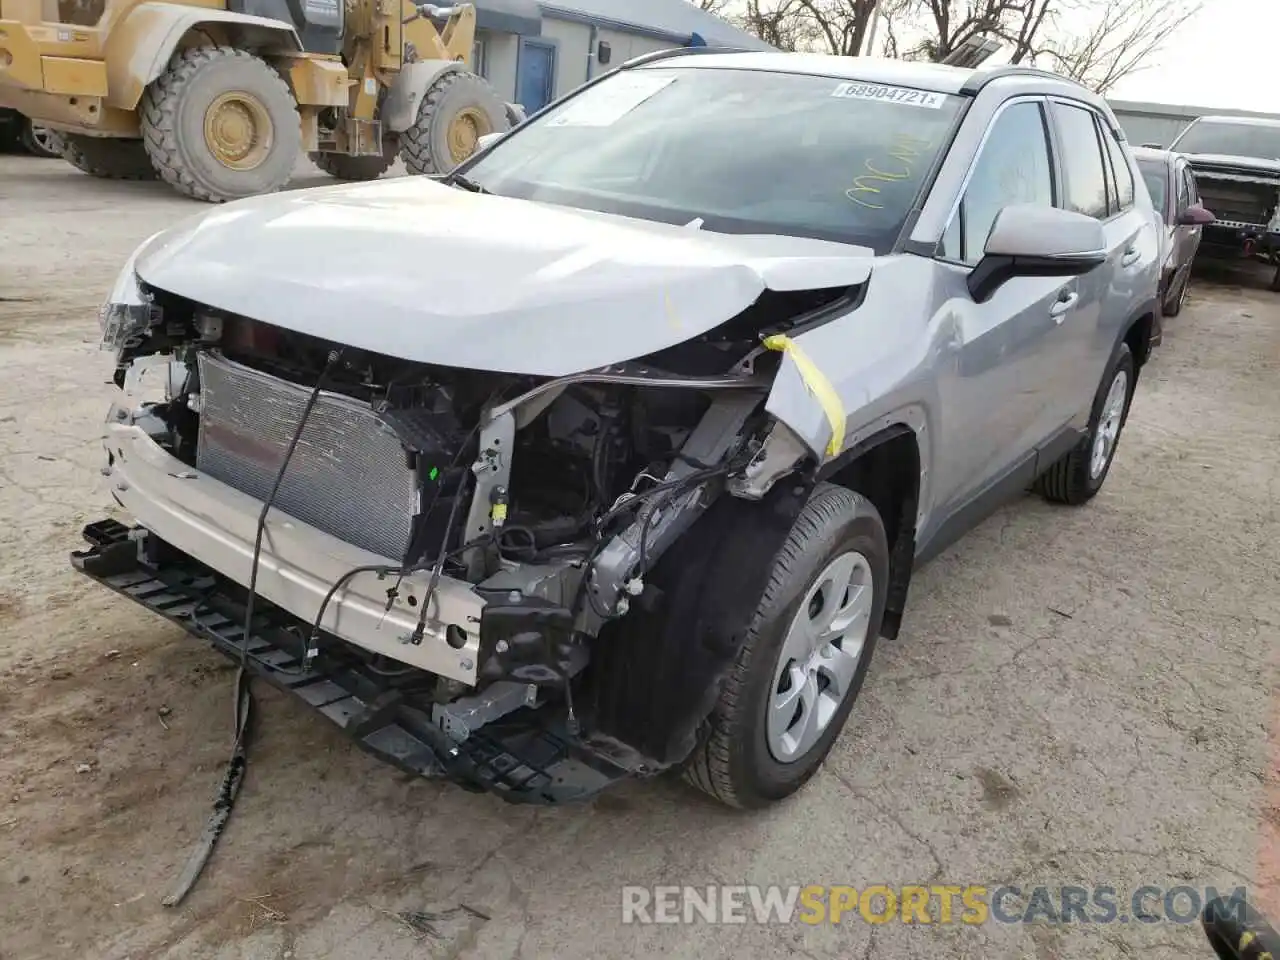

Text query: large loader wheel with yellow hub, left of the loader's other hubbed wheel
(141, 46), (302, 204)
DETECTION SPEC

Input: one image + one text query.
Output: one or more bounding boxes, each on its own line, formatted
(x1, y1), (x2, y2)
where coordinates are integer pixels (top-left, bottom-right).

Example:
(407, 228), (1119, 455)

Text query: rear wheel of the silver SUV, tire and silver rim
(1036, 343), (1137, 506)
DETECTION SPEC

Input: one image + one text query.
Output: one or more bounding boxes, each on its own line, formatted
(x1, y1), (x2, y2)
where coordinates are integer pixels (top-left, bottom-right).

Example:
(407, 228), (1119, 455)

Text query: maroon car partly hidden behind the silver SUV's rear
(1133, 147), (1213, 316)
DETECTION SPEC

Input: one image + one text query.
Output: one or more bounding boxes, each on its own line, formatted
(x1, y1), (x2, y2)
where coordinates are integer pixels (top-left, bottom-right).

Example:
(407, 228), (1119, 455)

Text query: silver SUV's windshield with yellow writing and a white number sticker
(463, 67), (960, 252)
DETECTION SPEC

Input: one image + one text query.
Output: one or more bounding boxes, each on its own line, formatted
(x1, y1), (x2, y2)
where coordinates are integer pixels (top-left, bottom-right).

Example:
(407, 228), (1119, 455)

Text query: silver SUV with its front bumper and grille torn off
(74, 52), (1160, 806)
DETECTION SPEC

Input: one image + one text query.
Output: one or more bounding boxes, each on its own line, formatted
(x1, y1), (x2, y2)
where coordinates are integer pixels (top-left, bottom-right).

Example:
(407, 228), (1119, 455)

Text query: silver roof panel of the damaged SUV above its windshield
(632, 47), (1097, 100)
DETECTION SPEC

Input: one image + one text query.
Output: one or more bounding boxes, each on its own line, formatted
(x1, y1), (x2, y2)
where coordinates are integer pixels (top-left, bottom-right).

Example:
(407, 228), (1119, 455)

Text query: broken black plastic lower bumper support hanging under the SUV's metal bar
(72, 520), (628, 804)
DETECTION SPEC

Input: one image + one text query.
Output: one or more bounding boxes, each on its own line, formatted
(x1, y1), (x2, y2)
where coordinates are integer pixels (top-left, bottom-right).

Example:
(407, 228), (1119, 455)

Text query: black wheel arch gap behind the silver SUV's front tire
(818, 421), (927, 640)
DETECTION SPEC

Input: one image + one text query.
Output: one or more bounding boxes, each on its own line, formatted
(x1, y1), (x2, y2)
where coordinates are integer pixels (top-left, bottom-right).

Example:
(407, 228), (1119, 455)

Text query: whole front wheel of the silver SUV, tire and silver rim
(685, 484), (888, 809)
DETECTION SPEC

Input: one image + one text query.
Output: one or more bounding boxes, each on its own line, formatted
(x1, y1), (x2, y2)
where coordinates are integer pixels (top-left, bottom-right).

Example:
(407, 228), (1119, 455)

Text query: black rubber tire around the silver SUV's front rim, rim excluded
(684, 484), (888, 809)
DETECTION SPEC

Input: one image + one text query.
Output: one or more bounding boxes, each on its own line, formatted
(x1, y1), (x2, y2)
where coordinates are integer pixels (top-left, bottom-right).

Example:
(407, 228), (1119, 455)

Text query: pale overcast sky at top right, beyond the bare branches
(1111, 0), (1280, 114)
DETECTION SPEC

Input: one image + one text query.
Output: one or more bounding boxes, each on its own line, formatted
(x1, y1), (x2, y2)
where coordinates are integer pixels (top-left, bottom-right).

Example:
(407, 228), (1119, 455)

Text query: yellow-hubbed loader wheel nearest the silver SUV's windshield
(401, 70), (511, 175)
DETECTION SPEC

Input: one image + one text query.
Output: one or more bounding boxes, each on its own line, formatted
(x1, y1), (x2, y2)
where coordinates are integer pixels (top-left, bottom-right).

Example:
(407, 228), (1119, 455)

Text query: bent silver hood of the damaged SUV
(136, 177), (874, 376)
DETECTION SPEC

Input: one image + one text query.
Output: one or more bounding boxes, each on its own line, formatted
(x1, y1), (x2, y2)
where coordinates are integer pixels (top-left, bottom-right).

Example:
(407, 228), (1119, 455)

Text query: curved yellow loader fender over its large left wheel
(104, 3), (302, 110)
